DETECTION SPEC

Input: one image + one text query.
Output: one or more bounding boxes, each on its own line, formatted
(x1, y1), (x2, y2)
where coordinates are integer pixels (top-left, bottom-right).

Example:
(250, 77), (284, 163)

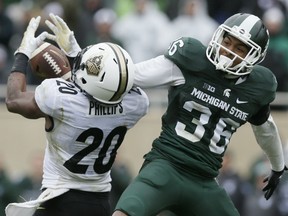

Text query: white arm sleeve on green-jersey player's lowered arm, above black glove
(251, 115), (284, 171)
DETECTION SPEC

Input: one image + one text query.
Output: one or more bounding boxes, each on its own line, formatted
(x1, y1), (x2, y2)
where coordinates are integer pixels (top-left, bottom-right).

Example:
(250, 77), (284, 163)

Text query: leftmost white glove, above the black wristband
(14, 16), (48, 59)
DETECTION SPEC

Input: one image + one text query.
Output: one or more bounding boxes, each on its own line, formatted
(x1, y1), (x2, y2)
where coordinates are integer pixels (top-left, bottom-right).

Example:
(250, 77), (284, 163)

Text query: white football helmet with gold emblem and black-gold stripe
(72, 43), (135, 104)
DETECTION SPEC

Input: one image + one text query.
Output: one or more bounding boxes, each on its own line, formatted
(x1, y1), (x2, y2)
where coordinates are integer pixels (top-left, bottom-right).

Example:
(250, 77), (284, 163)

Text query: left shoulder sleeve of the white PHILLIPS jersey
(35, 79), (61, 117)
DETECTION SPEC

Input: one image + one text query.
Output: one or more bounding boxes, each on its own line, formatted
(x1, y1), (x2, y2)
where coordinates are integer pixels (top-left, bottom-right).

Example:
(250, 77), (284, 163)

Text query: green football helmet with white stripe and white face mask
(206, 13), (269, 78)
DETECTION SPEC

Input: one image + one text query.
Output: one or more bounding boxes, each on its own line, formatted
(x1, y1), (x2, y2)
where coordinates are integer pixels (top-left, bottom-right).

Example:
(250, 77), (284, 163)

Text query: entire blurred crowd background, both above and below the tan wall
(0, 0), (288, 216)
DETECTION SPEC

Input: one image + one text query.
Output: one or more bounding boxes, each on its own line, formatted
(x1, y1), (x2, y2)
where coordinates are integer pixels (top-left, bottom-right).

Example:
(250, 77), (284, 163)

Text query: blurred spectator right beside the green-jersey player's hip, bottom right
(217, 151), (251, 215)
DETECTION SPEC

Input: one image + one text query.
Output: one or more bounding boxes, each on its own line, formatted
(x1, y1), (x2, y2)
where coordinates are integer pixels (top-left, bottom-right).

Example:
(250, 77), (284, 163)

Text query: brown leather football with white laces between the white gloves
(29, 42), (71, 80)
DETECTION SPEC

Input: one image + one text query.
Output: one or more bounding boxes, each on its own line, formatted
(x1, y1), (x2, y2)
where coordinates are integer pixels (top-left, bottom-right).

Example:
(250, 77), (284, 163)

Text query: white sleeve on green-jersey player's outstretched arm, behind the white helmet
(134, 55), (185, 88)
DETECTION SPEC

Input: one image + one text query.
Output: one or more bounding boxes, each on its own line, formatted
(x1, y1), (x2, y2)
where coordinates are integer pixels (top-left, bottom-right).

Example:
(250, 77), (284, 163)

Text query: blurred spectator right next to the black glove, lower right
(243, 155), (279, 216)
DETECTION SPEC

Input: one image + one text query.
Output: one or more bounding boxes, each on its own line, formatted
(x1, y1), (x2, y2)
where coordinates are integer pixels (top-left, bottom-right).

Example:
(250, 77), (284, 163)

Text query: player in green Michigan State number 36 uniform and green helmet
(46, 14), (285, 216)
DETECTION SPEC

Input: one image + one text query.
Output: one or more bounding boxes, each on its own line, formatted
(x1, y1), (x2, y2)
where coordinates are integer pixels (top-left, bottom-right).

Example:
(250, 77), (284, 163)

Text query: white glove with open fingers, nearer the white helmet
(45, 13), (81, 57)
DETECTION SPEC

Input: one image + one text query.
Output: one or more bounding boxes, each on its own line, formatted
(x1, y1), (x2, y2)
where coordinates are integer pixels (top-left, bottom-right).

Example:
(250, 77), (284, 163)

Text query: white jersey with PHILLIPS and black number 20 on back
(35, 78), (149, 192)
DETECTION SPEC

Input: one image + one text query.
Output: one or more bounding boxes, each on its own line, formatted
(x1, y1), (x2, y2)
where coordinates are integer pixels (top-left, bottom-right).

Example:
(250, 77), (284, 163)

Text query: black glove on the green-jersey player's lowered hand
(262, 166), (287, 200)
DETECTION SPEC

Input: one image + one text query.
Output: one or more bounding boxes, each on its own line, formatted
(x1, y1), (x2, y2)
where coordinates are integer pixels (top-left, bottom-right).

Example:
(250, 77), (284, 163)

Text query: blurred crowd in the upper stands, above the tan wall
(0, 0), (288, 91)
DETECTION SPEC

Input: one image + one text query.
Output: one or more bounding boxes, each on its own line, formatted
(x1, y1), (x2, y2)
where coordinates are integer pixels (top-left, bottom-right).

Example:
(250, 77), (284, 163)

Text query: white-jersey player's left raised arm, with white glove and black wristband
(6, 17), (47, 119)
